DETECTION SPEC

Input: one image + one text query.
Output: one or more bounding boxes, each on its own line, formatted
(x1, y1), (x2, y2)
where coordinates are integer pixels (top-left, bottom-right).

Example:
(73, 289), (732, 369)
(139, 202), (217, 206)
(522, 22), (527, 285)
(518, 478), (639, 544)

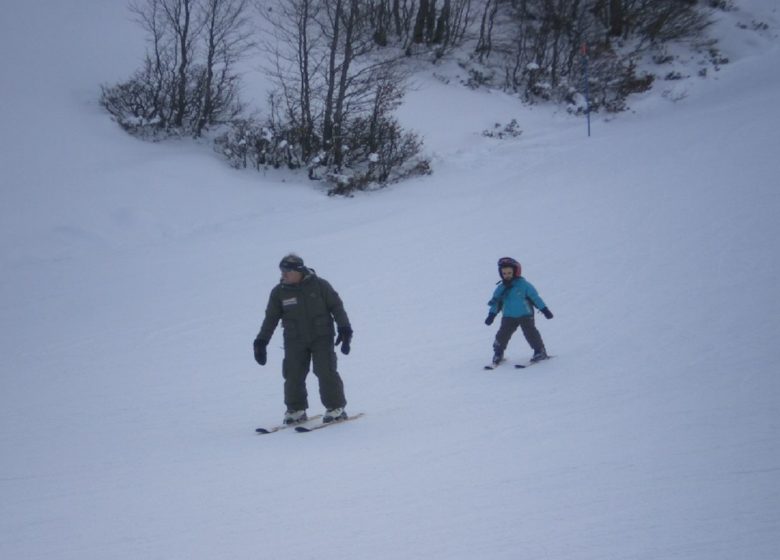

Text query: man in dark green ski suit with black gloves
(254, 254), (352, 424)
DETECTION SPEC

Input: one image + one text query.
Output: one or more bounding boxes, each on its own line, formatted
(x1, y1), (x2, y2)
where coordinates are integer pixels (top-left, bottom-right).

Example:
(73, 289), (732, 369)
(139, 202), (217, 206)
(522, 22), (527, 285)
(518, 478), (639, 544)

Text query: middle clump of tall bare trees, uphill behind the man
(256, 0), (426, 192)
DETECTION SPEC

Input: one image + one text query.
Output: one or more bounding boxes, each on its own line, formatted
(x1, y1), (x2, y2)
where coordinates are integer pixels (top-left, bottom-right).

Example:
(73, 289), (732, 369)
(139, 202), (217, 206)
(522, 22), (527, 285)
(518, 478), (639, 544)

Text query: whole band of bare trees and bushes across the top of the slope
(101, 0), (731, 194)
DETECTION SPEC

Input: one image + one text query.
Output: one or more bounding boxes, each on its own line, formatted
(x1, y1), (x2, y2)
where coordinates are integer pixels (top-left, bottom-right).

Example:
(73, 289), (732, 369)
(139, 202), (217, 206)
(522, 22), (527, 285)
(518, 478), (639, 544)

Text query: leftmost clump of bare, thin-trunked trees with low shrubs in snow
(101, 0), (251, 136)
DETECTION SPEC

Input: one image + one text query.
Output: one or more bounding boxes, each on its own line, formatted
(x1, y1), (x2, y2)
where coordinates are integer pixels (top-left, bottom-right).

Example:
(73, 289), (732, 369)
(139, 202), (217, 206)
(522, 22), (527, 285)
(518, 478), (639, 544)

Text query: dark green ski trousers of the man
(282, 337), (347, 410)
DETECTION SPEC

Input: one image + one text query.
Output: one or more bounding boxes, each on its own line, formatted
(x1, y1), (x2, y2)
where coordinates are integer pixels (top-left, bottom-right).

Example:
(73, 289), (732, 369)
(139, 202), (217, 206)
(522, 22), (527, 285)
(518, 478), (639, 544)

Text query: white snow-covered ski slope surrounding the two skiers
(0, 0), (780, 560)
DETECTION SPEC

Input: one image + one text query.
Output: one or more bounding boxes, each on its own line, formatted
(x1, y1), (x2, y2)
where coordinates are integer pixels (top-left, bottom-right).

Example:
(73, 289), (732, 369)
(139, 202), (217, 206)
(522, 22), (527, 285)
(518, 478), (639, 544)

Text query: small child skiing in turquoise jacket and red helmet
(485, 257), (553, 366)
